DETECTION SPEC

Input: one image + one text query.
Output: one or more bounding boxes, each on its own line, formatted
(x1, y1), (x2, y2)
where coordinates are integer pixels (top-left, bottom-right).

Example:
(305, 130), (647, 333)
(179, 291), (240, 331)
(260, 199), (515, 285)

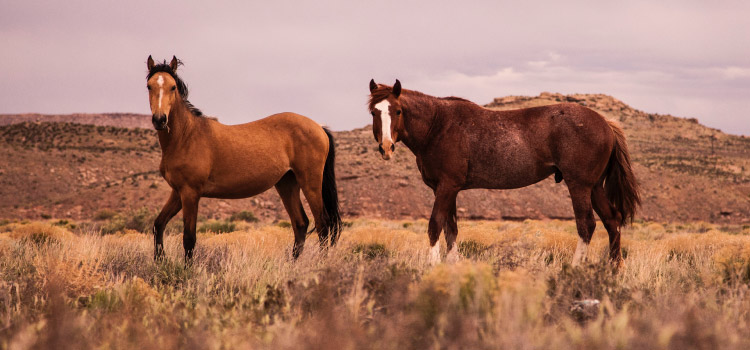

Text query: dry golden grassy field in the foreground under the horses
(0, 220), (750, 350)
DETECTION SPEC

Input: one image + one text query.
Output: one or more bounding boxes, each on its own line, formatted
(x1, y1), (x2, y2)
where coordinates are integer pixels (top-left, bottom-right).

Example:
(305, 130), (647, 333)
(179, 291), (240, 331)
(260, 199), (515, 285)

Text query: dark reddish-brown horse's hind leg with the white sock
(568, 183), (596, 266)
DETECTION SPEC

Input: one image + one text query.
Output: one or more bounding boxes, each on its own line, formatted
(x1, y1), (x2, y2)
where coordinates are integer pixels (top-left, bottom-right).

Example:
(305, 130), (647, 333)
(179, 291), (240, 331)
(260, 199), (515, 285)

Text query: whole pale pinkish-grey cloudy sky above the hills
(0, 0), (750, 135)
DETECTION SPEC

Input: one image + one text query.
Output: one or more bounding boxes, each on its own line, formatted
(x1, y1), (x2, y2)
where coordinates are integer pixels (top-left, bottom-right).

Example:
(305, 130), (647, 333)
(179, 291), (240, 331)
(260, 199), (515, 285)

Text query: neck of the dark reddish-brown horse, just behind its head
(401, 95), (443, 155)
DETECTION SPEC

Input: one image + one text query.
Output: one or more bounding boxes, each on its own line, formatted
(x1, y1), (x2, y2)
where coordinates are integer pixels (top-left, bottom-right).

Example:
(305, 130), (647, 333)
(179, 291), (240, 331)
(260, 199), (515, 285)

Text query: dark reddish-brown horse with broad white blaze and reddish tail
(369, 80), (640, 265)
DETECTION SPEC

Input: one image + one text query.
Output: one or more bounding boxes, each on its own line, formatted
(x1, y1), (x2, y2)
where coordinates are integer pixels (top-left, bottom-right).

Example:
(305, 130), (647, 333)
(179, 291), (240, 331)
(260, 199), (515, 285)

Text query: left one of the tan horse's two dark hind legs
(276, 171), (310, 259)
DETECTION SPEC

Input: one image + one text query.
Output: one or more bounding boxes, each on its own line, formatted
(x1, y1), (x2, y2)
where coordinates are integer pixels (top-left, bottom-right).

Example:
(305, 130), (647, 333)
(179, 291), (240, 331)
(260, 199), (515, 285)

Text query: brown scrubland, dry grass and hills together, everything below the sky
(0, 93), (750, 350)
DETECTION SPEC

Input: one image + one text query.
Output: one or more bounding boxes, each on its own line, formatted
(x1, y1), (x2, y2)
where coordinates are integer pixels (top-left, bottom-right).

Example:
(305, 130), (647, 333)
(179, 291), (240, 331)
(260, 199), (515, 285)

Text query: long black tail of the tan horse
(323, 128), (342, 245)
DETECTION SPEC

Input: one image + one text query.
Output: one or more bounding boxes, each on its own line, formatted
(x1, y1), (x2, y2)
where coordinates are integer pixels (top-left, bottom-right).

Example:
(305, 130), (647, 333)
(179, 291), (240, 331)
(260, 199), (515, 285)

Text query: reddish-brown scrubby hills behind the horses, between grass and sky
(0, 93), (750, 223)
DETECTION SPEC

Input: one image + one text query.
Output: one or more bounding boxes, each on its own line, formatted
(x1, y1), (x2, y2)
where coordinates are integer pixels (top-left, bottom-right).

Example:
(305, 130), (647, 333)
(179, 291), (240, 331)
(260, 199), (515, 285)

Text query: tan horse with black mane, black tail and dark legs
(146, 56), (341, 260)
